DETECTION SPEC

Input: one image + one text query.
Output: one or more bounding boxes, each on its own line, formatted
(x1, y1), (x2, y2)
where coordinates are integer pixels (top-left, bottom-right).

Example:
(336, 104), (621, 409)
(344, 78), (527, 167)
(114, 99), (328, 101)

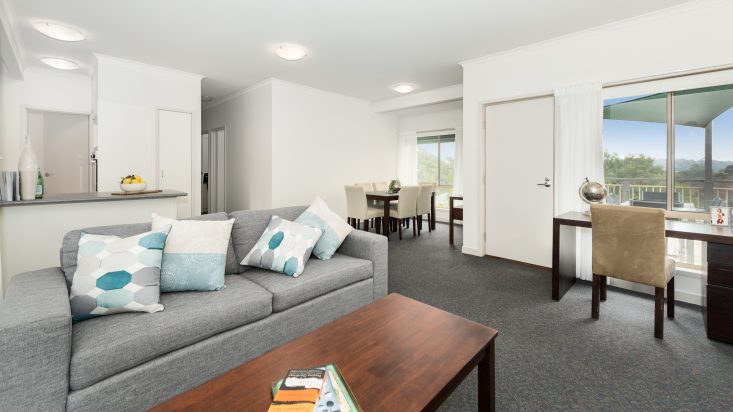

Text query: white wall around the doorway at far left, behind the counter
(0, 67), (92, 170)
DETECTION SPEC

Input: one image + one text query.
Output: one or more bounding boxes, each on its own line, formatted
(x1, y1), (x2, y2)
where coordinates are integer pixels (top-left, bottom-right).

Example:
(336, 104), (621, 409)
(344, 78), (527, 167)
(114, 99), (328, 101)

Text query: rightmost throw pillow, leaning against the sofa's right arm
(295, 197), (354, 260)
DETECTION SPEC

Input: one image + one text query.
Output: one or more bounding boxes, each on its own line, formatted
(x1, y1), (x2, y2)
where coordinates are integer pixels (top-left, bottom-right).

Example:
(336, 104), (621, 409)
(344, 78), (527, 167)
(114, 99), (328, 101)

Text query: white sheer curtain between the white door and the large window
(555, 83), (604, 280)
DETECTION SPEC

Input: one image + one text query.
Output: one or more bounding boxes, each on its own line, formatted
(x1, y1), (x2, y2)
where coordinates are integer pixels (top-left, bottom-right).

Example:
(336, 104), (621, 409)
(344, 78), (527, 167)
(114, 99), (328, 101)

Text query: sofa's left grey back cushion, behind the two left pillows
(61, 212), (241, 286)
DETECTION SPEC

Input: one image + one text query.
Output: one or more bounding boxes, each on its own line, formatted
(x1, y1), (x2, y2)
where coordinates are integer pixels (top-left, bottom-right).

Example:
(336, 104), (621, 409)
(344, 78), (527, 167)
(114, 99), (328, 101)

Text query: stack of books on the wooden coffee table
(268, 364), (362, 412)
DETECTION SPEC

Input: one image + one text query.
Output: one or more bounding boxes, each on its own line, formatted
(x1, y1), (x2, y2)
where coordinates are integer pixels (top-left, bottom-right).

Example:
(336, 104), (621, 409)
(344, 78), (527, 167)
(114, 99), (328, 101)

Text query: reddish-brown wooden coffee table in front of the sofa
(153, 293), (498, 411)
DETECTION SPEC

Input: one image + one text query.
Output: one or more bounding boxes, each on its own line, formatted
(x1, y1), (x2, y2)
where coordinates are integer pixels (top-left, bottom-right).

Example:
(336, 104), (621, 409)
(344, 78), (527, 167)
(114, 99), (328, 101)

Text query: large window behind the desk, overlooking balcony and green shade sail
(603, 85), (733, 270)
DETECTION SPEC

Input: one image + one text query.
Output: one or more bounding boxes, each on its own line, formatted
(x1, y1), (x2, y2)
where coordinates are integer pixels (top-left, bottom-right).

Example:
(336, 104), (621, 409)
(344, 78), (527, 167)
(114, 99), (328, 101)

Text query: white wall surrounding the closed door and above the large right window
(462, 1), (733, 256)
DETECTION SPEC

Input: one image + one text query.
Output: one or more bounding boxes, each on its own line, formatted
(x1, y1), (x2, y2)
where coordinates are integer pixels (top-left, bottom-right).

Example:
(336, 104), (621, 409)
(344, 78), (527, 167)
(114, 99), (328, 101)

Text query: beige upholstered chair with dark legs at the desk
(591, 205), (674, 339)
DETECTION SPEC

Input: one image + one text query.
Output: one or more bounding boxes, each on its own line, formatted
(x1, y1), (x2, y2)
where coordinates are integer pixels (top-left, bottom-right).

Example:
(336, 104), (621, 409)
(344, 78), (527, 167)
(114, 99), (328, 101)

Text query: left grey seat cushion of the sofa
(70, 275), (272, 390)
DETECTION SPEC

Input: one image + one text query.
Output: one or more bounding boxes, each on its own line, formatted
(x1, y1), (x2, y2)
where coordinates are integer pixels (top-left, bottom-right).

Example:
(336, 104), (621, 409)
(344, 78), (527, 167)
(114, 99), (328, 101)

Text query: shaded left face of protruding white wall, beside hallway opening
(201, 80), (272, 212)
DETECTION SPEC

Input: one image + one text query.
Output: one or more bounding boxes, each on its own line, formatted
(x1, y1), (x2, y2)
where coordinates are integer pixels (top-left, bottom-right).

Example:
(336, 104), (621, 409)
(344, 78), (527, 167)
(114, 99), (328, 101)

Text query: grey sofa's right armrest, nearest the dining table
(338, 230), (388, 300)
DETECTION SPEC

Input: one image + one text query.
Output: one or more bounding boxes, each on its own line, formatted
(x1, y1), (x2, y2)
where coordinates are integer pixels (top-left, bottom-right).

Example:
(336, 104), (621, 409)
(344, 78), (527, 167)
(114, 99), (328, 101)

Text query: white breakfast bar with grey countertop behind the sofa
(0, 190), (187, 290)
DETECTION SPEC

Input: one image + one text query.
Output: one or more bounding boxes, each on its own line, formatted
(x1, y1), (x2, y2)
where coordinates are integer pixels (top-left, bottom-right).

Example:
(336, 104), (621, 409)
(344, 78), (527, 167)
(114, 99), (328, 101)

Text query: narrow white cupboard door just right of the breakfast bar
(158, 109), (193, 218)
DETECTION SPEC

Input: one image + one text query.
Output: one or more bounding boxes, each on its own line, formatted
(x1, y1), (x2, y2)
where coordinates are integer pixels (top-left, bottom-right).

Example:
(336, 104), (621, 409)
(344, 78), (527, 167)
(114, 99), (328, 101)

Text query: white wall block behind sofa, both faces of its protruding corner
(202, 79), (397, 216)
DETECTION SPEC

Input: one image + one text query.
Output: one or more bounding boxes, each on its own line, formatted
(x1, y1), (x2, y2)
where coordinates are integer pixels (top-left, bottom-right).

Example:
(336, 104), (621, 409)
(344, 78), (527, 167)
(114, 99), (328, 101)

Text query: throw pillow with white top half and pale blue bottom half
(152, 213), (234, 292)
